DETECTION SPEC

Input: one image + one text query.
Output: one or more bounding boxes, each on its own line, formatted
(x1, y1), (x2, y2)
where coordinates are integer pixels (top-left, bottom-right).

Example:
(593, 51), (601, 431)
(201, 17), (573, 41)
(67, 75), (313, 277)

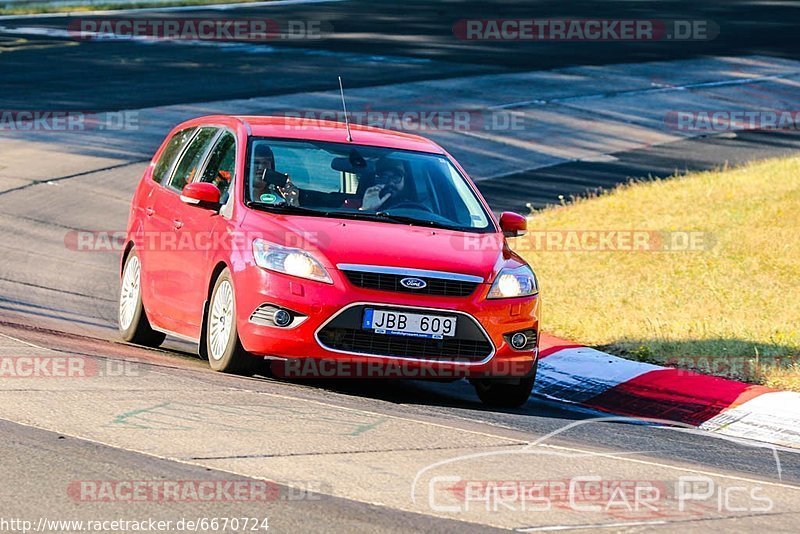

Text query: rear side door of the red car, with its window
(148, 127), (219, 338)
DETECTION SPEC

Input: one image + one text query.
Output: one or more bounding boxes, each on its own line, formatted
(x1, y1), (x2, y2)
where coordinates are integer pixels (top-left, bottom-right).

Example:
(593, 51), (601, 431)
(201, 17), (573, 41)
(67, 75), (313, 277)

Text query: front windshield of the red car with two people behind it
(245, 138), (494, 232)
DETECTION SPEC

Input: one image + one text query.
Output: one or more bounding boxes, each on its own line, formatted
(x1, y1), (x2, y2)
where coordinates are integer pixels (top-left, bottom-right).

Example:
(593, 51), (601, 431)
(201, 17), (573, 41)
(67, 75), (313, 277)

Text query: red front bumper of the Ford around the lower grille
(234, 265), (539, 378)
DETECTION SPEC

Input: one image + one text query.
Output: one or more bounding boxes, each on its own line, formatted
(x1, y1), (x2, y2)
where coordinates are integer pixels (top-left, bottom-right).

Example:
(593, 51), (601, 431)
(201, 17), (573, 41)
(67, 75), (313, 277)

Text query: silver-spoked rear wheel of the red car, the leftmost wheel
(117, 250), (167, 348)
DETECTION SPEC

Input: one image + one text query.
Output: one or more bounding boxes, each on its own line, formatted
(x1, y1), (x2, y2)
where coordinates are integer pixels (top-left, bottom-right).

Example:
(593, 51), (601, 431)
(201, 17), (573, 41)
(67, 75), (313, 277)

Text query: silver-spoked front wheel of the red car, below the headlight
(202, 268), (254, 373)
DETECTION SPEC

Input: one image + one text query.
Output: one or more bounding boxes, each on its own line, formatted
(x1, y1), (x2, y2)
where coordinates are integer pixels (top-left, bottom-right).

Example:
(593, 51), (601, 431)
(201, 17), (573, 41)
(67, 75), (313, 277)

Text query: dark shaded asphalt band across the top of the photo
(0, 0), (800, 111)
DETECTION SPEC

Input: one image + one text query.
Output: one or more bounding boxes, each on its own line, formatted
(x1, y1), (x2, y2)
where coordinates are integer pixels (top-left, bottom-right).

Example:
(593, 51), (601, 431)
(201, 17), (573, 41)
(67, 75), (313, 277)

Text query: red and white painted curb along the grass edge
(536, 334), (800, 448)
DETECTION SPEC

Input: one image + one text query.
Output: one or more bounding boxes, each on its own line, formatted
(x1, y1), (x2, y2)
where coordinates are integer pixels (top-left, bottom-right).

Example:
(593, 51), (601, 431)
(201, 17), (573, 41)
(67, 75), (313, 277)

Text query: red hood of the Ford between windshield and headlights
(243, 212), (516, 282)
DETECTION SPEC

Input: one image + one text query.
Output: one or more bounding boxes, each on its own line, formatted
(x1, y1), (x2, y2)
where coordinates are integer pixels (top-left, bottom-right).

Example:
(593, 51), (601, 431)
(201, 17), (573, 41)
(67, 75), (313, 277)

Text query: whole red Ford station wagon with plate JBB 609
(119, 116), (539, 406)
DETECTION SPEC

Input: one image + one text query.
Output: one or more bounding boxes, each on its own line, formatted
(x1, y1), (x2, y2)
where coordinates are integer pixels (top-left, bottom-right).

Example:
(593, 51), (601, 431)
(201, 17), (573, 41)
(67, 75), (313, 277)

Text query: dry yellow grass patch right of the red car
(512, 157), (800, 391)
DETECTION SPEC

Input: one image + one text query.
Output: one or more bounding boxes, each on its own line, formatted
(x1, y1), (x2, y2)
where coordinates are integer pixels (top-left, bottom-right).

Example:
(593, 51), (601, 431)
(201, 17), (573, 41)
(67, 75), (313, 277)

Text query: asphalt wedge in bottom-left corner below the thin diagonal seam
(0, 421), (494, 533)
